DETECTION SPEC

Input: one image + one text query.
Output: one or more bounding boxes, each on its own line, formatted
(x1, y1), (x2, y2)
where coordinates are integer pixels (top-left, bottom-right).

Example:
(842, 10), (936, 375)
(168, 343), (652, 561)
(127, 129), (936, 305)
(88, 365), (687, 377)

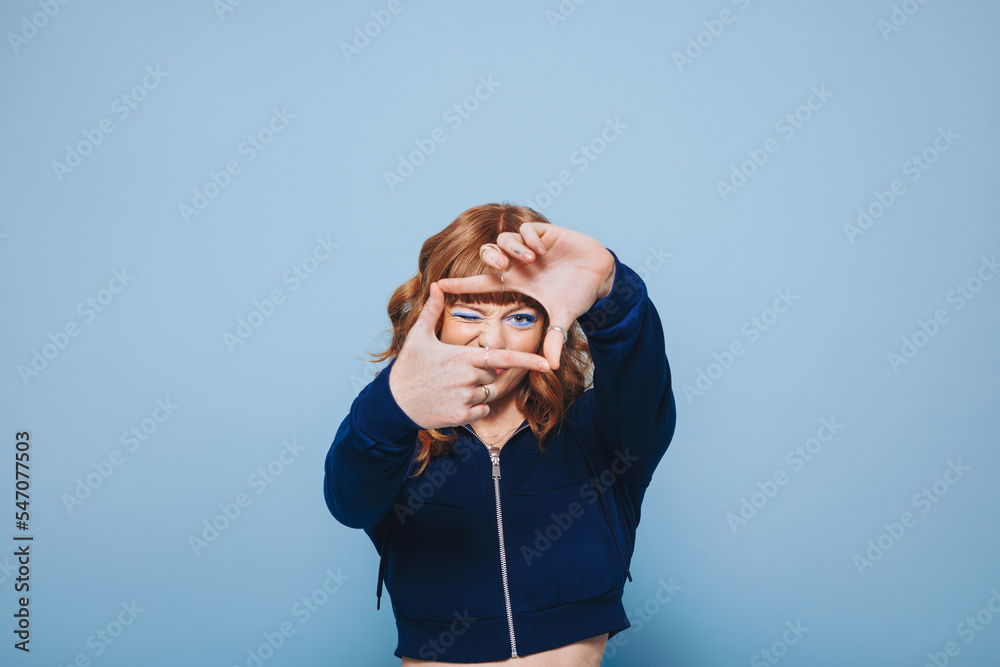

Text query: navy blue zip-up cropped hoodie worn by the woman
(324, 252), (676, 663)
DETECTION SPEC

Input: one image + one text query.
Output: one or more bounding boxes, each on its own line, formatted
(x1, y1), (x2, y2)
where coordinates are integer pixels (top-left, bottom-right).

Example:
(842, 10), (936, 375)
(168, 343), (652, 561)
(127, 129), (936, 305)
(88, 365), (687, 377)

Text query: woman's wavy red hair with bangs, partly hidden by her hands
(368, 203), (593, 476)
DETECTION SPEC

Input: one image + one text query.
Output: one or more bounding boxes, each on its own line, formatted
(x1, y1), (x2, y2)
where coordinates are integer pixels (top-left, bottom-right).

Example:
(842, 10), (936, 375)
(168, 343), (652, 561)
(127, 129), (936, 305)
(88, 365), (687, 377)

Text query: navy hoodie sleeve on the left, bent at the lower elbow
(323, 359), (420, 528)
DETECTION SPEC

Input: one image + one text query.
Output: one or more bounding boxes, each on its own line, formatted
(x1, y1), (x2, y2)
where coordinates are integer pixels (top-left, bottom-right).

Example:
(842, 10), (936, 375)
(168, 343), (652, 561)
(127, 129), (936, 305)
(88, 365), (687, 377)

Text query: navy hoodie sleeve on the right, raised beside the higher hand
(577, 250), (676, 488)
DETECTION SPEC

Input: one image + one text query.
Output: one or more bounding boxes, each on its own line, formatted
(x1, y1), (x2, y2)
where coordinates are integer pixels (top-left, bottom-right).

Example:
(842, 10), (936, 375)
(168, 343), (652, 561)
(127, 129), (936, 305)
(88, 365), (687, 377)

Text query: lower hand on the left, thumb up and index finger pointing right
(389, 283), (549, 429)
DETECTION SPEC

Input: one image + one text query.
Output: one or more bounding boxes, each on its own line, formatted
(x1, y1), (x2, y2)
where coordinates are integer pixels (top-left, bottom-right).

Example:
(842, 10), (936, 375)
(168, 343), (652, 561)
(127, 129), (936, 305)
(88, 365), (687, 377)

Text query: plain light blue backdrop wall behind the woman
(0, 0), (1000, 667)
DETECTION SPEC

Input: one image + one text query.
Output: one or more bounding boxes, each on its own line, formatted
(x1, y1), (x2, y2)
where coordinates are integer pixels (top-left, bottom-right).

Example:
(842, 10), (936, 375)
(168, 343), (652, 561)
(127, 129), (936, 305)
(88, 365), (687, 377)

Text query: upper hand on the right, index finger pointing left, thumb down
(437, 222), (615, 368)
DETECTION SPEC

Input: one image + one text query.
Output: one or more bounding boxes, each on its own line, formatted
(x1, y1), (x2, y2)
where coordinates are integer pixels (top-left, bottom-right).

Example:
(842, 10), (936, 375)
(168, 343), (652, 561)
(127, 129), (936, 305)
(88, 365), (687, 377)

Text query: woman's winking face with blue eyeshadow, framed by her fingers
(440, 301), (542, 402)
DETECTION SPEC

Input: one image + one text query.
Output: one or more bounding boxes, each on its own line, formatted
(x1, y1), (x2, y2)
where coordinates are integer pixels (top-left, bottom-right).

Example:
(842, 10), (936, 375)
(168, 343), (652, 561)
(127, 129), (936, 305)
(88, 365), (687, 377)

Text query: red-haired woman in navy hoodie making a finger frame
(325, 204), (676, 667)
